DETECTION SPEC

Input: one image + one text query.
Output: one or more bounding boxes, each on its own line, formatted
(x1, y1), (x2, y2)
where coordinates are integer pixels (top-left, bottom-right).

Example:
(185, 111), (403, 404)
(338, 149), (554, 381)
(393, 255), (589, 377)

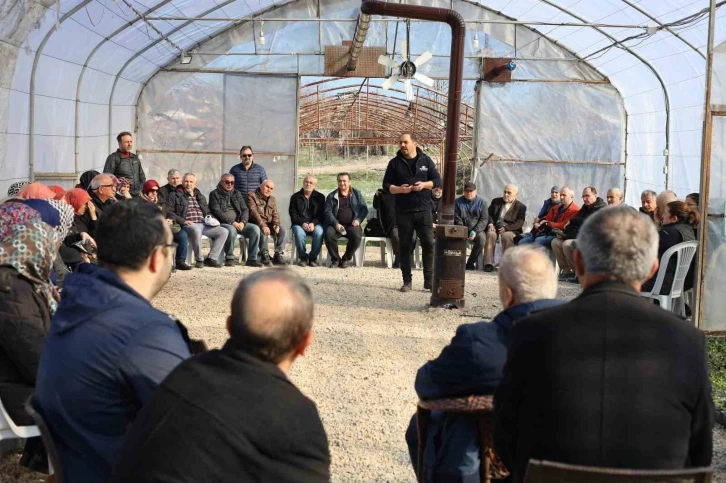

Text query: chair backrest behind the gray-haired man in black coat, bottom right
(524, 460), (713, 483)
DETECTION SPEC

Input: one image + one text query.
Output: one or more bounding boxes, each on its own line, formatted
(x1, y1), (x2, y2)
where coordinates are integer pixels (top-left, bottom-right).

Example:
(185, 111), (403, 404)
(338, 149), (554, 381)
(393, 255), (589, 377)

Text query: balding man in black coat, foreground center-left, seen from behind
(109, 268), (330, 483)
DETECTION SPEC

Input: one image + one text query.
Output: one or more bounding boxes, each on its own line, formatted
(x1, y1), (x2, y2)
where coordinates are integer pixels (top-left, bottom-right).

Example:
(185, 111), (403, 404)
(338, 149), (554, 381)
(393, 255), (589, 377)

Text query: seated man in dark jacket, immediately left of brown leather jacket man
(209, 173), (262, 267)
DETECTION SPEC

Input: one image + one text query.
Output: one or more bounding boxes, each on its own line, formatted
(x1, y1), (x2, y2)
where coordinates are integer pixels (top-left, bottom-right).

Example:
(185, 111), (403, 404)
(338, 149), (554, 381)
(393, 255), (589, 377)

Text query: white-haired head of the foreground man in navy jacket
(499, 245), (557, 304)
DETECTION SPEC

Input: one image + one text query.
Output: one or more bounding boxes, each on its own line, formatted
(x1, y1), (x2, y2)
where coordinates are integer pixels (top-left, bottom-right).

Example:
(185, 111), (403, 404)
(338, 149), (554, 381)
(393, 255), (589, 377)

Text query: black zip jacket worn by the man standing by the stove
(383, 148), (441, 213)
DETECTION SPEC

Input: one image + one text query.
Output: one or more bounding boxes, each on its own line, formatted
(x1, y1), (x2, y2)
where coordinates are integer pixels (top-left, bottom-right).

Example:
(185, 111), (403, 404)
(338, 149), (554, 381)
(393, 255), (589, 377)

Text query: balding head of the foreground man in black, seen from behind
(229, 268), (314, 364)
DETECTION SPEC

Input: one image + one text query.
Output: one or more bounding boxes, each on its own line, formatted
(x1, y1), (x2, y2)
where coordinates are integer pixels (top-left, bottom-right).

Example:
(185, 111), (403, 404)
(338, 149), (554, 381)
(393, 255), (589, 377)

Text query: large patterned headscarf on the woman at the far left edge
(0, 220), (60, 315)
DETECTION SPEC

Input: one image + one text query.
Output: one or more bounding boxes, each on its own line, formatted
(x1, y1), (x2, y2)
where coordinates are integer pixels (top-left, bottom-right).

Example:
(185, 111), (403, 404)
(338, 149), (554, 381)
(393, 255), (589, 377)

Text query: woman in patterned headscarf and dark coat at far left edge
(0, 202), (59, 472)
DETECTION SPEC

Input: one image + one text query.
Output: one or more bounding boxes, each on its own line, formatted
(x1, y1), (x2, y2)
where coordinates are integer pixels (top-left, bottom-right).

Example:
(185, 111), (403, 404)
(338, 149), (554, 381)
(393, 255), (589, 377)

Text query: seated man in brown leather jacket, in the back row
(247, 179), (290, 267)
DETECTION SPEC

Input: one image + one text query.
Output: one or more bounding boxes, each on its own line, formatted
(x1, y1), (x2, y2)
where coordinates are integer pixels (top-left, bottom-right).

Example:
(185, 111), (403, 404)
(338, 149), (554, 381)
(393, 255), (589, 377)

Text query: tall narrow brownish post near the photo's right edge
(694, 0), (716, 328)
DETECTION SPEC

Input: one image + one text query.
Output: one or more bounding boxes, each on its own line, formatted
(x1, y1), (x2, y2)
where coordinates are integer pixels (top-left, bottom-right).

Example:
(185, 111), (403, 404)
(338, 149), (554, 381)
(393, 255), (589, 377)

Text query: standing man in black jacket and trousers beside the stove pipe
(383, 133), (441, 292)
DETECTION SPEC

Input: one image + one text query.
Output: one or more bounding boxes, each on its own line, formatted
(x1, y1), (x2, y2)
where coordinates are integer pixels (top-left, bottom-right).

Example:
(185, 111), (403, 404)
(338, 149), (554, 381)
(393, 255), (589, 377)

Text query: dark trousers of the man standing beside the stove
(396, 210), (434, 284)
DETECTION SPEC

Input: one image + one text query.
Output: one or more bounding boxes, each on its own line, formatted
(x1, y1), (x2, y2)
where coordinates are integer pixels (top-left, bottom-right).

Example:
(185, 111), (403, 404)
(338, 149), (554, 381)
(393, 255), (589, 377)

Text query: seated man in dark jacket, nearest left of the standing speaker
(325, 173), (368, 268)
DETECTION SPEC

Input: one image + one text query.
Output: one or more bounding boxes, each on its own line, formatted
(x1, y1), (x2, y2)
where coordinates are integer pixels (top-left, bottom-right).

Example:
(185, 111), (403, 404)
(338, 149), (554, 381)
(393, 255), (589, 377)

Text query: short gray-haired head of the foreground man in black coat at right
(577, 206), (658, 283)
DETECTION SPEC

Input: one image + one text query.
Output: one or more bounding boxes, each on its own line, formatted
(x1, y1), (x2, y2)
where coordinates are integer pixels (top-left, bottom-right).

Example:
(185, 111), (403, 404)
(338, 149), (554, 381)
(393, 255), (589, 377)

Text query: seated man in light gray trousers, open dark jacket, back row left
(166, 173), (229, 268)
